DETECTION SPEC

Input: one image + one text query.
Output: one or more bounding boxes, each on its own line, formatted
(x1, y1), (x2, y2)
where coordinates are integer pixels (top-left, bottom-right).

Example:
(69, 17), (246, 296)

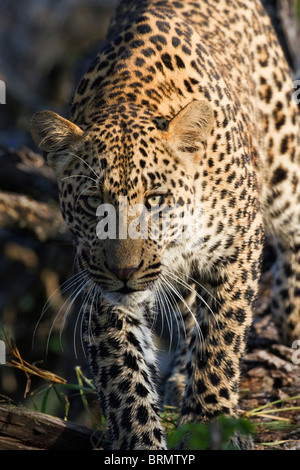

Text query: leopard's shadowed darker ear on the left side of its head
(30, 111), (84, 171)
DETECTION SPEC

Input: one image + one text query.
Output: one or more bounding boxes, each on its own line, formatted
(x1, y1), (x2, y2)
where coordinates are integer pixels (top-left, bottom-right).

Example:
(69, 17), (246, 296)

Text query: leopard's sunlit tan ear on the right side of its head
(166, 100), (214, 157)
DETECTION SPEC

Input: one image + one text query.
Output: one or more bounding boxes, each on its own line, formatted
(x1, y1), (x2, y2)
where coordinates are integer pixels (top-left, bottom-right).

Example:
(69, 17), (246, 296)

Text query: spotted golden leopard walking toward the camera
(31, 0), (300, 450)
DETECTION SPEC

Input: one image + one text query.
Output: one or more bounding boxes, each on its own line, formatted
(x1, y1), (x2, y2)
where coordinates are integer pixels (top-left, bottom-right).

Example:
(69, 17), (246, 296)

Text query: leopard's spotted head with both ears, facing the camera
(31, 101), (213, 303)
